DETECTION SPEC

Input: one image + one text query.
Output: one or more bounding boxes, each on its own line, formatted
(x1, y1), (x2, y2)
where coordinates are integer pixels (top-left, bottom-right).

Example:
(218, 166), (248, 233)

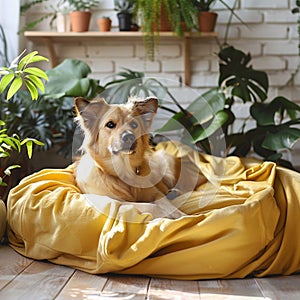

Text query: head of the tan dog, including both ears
(75, 97), (158, 158)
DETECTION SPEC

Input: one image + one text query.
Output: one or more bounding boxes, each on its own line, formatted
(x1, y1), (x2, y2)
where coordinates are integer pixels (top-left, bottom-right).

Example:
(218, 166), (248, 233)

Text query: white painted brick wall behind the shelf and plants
(24, 0), (300, 165)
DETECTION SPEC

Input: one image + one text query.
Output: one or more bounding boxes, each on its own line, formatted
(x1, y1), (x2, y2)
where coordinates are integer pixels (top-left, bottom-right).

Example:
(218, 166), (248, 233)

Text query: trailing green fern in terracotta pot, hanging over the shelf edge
(136, 0), (197, 60)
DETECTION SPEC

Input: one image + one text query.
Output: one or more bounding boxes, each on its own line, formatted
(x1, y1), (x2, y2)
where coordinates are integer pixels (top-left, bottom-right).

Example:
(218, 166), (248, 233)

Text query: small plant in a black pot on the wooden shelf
(115, 0), (135, 31)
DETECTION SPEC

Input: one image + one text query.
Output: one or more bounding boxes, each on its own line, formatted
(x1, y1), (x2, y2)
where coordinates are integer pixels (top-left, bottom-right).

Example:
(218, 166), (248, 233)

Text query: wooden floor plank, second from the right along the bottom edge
(198, 279), (265, 300)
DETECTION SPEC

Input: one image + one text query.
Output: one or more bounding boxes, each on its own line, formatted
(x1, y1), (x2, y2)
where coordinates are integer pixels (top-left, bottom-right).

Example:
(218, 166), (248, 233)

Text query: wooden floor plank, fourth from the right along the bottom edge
(99, 275), (150, 300)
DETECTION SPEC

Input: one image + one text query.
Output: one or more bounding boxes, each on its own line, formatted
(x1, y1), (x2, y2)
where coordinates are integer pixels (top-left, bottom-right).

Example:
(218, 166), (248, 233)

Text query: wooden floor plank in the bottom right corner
(256, 275), (300, 300)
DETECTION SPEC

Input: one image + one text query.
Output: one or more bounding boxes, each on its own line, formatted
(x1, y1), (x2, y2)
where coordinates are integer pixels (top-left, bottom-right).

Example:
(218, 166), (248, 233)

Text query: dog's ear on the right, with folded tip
(133, 97), (158, 126)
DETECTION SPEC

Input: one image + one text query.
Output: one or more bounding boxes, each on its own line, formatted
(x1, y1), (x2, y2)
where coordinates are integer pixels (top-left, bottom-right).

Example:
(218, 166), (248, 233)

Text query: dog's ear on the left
(74, 97), (109, 130)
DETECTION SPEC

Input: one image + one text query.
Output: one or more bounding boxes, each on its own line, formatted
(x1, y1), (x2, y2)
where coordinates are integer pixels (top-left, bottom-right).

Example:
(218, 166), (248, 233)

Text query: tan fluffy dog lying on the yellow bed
(74, 97), (205, 202)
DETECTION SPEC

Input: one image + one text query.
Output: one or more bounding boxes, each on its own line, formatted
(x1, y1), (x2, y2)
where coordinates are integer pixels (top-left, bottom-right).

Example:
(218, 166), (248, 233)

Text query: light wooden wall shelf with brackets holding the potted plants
(24, 31), (217, 85)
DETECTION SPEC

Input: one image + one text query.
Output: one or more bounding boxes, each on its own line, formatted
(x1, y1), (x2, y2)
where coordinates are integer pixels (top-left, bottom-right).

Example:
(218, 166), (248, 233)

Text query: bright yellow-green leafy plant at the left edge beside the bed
(0, 51), (47, 242)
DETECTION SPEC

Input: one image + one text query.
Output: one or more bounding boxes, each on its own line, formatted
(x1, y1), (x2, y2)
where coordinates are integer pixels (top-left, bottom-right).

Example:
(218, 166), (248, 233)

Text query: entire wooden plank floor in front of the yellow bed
(0, 245), (300, 300)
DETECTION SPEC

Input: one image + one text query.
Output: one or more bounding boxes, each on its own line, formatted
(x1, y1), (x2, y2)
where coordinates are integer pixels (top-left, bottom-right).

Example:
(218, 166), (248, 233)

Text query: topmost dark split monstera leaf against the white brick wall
(219, 47), (269, 102)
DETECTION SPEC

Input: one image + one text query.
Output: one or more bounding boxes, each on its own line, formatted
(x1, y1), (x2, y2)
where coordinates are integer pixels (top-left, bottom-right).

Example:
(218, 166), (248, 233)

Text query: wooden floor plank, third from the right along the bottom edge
(147, 278), (200, 300)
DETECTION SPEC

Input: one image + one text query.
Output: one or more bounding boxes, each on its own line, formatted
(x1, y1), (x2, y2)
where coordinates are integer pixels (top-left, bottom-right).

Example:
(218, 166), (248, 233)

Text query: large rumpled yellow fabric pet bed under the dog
(7, 144), (300, 280)
